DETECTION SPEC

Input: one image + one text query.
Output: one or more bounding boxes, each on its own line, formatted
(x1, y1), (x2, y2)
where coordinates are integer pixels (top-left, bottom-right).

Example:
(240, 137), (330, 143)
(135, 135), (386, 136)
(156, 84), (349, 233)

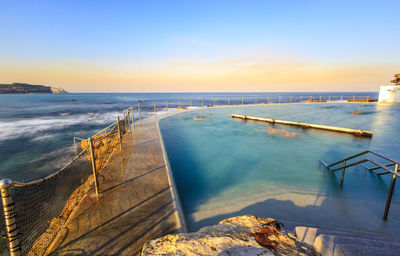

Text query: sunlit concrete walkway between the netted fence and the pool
(48, 120), (182, 255)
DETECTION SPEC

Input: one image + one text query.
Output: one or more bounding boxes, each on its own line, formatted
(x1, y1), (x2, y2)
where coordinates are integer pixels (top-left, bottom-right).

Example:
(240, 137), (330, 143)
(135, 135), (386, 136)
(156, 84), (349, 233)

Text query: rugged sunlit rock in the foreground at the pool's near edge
(141, 215), (317, 256)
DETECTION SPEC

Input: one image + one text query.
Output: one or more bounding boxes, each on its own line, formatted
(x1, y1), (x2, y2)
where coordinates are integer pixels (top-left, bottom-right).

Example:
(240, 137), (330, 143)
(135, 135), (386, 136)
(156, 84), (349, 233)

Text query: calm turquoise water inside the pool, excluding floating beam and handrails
(160, 103), (400, 233)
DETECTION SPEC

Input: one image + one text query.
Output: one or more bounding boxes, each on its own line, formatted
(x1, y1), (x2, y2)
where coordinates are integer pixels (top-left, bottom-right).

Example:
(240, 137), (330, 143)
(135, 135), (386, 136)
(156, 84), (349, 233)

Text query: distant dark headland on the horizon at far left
(0, 83), (68, 94)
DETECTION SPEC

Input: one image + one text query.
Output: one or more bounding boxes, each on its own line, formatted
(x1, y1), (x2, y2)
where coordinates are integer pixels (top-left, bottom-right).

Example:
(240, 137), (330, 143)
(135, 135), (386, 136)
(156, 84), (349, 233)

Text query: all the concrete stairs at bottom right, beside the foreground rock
(295, 226), (400, 256)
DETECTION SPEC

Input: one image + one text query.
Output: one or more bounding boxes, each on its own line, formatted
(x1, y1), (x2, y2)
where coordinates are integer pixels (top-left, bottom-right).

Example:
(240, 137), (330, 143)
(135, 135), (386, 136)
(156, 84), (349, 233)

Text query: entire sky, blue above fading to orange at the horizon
(0, 0), (400, 92)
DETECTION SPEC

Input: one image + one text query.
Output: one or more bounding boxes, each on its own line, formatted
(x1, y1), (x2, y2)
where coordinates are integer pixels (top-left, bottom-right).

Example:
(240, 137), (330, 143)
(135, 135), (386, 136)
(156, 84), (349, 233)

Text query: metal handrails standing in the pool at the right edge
(320, 150), (400, 220)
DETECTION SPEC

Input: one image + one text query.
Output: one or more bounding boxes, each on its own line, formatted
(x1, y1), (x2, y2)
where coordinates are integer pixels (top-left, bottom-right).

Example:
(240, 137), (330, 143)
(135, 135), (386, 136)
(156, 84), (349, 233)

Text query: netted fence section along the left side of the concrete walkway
(0, 107), (134, 255)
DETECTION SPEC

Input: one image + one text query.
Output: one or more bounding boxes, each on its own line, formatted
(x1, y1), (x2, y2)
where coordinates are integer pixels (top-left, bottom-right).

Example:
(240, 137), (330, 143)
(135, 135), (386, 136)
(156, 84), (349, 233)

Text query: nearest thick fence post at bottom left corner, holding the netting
(0, 179), (21, 256)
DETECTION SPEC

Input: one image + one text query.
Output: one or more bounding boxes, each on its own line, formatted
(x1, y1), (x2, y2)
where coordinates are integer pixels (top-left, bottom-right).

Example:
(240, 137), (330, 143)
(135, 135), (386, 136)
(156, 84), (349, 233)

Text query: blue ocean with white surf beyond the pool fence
(0, 93), (377, 181)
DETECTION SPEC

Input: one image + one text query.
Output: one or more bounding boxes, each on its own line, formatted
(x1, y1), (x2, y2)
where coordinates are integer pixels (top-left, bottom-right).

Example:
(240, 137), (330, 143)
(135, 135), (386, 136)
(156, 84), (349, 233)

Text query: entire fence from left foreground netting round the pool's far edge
(0, 95), (376, 255)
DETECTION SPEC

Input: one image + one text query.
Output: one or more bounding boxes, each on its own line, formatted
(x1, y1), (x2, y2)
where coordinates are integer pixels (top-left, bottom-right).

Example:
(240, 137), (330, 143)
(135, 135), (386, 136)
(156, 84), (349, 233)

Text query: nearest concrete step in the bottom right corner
(314, 234), (400, 256)
